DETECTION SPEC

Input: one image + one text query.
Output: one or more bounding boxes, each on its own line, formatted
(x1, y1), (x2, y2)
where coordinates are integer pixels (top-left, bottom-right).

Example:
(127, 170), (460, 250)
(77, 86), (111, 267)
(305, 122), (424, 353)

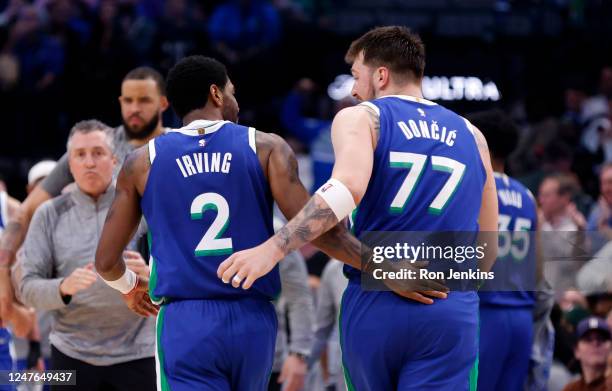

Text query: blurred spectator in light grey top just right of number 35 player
(538, 174), (586, 293)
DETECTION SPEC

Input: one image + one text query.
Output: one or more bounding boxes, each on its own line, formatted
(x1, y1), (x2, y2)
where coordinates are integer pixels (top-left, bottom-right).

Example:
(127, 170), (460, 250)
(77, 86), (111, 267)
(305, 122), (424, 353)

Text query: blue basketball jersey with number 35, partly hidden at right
(479, 173), (537, 307)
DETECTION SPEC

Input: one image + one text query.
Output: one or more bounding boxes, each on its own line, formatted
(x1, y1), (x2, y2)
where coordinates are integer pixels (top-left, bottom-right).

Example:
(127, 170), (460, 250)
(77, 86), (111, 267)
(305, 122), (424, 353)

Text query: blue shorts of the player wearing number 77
(340, 282), (478, 391)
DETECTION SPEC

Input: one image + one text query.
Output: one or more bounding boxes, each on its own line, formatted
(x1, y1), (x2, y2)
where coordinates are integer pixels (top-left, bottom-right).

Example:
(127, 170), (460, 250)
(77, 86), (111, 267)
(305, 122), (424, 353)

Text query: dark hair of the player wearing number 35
(467, 109), (519, 160)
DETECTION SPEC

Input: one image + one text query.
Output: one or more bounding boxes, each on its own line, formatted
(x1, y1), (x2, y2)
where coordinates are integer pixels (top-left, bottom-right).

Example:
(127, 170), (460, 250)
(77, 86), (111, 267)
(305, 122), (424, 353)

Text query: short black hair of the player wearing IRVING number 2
(166, 56), (229, 118)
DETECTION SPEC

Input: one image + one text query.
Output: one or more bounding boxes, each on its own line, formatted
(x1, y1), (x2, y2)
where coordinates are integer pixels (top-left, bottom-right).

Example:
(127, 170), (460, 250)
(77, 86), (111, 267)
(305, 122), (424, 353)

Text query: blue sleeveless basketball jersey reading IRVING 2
(141, 120), (280, 302)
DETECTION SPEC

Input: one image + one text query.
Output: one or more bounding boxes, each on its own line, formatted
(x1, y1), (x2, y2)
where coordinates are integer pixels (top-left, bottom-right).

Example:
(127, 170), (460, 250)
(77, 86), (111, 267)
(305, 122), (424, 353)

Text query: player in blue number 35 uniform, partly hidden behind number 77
(469, 110), (541, 391)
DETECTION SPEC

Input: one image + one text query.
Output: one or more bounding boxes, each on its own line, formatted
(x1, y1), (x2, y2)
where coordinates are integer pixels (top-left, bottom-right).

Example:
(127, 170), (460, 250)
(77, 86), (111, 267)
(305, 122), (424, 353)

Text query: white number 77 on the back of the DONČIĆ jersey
(389, 152), (465, 215)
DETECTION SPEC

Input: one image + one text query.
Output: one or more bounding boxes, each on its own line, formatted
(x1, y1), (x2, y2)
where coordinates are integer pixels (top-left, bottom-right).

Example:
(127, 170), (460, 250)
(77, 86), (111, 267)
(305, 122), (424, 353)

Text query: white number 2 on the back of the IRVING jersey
(191, 193), (233, 257)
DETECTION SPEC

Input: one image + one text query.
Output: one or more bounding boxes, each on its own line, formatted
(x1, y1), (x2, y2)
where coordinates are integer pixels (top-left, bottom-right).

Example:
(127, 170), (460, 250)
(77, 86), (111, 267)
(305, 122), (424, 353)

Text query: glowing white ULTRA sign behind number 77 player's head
(327, 75), (501, 102)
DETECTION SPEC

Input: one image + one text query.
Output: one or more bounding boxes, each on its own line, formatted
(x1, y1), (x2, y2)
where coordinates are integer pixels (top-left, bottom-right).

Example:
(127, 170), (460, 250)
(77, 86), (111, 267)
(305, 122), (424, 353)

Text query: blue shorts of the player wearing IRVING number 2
(156, 299), (278, 391)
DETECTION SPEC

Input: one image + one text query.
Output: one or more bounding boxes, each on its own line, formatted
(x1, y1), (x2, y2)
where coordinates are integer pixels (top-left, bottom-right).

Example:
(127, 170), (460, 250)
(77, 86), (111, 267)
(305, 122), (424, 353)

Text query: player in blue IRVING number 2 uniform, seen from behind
(96, 56), (368, 391)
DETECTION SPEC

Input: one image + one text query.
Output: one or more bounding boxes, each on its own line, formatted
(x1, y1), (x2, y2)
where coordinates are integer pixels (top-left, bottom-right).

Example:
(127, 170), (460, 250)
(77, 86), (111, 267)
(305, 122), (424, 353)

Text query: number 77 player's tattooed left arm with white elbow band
(217, 106), (378, 289)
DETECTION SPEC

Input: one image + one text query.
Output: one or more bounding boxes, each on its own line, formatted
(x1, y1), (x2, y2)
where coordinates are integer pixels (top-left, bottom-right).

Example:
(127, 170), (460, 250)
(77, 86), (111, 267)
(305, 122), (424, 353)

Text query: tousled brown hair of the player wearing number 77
(345, 26), (425, 80)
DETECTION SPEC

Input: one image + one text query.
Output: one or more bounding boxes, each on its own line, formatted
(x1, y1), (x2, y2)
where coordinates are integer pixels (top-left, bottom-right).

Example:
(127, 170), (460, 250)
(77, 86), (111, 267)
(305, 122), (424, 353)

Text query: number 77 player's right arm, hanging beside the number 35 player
(472, 125), (499, 272)
